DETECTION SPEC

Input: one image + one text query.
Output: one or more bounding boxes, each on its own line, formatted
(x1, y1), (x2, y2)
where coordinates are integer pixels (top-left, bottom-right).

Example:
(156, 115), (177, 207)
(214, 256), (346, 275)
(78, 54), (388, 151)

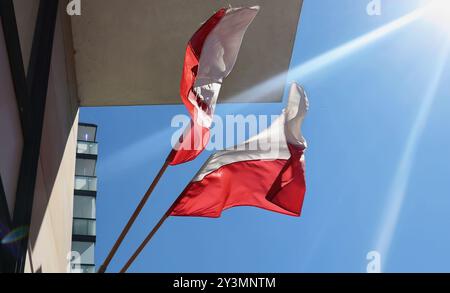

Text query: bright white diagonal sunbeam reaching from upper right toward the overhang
(227, 8), (425, 102)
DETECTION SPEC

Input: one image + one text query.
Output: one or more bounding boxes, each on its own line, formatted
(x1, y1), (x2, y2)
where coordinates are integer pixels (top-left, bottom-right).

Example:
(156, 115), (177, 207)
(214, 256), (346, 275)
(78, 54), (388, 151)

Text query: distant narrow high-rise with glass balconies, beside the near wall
(71, 123), (98, 273)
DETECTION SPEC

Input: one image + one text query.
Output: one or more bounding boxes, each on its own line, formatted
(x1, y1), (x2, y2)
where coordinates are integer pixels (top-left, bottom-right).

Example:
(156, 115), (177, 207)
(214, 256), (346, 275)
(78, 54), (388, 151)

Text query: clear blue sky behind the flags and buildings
(80, 0), (450, 272)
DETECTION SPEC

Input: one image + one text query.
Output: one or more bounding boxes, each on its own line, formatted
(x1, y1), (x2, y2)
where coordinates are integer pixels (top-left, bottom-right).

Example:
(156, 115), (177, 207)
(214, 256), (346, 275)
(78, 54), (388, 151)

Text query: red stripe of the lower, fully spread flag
(172, 159), (305, 218)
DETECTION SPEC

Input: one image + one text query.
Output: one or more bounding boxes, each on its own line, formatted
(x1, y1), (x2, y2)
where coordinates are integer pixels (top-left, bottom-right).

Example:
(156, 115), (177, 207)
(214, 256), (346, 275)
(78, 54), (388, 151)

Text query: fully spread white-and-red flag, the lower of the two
(171, 84), (308, 218)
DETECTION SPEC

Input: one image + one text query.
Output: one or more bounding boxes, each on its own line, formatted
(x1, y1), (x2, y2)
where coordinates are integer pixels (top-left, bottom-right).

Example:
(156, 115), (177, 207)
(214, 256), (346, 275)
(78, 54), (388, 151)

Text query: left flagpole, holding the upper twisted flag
(97, 150), (174, 273)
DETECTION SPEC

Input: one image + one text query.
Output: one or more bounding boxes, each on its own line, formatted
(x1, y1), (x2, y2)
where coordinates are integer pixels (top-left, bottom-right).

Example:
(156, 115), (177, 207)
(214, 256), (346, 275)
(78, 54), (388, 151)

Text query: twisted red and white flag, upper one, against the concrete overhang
(170, 6), (259, 165)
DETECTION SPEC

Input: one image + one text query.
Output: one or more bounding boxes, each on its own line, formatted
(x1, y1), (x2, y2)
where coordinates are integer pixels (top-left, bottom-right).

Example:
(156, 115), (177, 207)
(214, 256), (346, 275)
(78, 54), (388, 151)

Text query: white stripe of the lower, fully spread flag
(193, 84), (308, 181)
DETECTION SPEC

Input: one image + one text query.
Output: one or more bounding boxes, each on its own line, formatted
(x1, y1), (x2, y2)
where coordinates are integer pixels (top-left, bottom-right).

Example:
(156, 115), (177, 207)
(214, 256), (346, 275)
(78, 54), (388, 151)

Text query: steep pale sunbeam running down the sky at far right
(376, 40), (450, 267)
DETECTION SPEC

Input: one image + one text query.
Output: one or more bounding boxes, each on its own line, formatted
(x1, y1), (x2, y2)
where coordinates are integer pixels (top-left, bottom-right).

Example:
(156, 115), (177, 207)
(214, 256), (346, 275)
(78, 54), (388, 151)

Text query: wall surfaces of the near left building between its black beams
(0, 0), (78, 273)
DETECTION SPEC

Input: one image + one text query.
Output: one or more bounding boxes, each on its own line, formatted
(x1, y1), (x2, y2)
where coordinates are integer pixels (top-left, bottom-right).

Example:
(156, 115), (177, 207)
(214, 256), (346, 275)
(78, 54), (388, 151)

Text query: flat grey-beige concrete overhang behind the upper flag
(71, 0), (302, 106)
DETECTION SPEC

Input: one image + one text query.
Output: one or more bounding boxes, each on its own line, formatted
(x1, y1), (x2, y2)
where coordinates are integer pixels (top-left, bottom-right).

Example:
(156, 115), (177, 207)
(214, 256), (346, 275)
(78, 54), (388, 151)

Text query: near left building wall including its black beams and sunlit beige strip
(0, 0), (79, 273)
